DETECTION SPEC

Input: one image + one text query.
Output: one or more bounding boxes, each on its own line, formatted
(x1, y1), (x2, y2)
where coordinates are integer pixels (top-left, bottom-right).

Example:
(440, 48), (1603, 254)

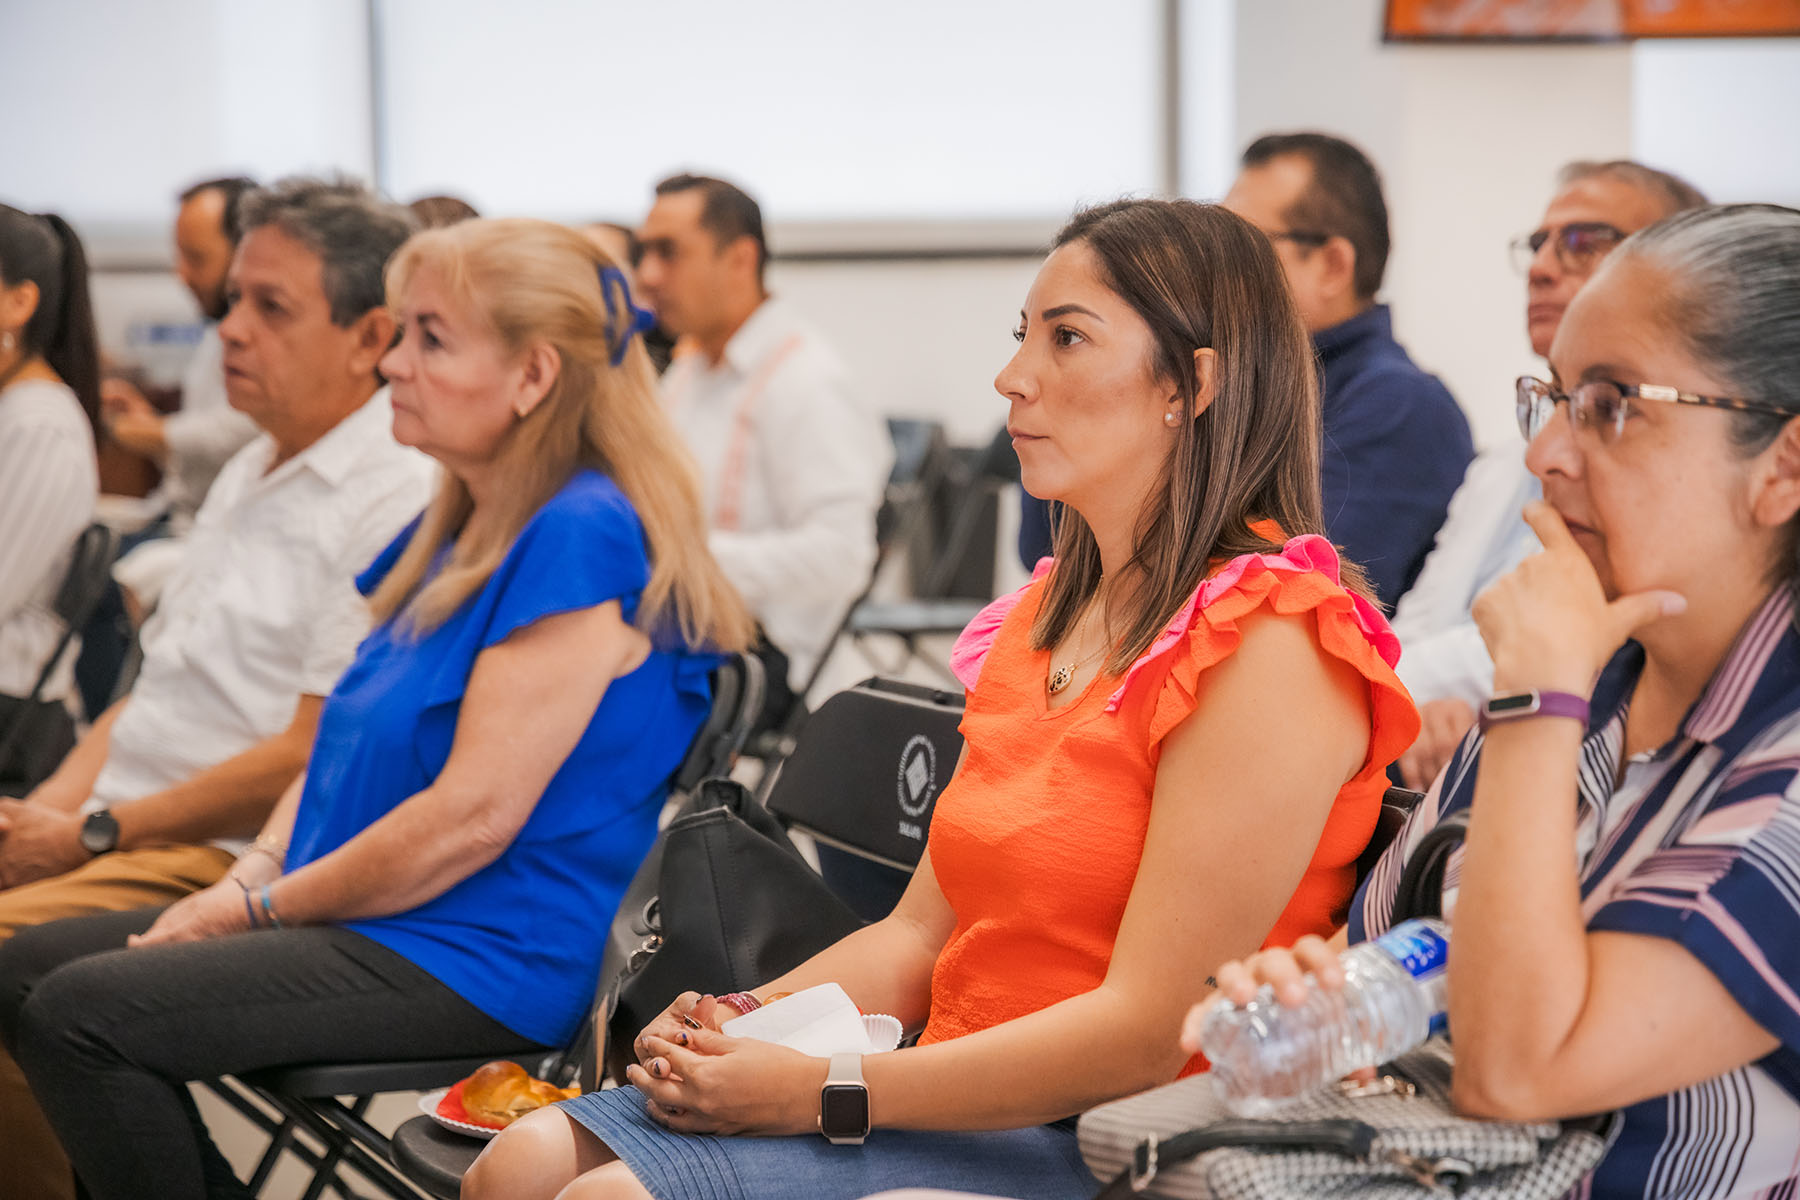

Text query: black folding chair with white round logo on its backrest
(392, 678), (963, 1200)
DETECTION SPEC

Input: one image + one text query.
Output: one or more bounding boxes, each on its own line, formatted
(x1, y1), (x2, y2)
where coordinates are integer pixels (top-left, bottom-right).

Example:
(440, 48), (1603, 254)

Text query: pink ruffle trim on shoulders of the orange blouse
(950, 534), (1400, 698)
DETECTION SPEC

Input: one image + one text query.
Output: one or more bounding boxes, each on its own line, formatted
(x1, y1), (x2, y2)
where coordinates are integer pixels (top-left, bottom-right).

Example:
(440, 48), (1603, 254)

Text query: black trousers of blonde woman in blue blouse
(0, 909), (535, 1200)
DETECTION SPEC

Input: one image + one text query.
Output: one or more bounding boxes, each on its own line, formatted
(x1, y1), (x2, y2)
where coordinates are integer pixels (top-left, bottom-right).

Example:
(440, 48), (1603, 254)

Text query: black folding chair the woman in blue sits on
(207, 655), (763, 1200)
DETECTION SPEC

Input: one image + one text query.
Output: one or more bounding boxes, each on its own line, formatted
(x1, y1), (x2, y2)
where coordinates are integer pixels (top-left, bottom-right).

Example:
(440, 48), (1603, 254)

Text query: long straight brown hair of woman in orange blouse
(1031, 200), (1366, 675)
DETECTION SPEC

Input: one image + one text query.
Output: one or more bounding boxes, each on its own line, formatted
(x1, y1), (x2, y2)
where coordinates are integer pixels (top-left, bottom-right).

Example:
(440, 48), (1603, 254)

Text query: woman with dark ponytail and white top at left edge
(0, 205), (101, 795)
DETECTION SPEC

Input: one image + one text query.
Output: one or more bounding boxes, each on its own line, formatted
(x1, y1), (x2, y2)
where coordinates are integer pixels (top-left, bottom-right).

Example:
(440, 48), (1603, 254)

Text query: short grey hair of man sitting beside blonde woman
(238, 176), (418, 327)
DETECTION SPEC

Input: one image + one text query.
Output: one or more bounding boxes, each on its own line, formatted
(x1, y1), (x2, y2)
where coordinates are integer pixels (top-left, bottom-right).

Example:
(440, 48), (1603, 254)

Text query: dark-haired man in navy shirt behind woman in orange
(1224, 133), (1474, 612)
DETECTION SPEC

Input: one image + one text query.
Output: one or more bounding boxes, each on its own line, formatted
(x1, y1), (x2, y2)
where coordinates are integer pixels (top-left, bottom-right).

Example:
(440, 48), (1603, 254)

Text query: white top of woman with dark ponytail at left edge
(0, 380), (99, 700)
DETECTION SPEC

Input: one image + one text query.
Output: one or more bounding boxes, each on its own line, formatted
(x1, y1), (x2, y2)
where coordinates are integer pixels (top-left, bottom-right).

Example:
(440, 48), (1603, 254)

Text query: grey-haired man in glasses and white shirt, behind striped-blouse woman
(1393, 160), (1706, 790)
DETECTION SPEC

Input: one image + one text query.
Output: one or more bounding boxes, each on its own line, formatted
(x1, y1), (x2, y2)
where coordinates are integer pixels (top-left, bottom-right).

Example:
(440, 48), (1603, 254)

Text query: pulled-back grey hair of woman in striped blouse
(1600, 203), (1800, 578)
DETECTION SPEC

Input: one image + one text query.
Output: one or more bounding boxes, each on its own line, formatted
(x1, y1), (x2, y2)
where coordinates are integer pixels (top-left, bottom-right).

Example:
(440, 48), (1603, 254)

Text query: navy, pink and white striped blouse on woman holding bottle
(1350, 587), (1800, 1200)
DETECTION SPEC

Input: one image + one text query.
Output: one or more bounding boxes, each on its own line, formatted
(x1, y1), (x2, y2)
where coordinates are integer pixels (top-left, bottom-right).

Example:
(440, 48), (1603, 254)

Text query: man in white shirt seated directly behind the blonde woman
(637, 175), (893, 720)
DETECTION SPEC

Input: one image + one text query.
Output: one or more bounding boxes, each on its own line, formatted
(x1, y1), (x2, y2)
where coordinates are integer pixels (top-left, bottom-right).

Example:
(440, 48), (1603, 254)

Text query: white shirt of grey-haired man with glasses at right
(1393, 446), (1543, 707)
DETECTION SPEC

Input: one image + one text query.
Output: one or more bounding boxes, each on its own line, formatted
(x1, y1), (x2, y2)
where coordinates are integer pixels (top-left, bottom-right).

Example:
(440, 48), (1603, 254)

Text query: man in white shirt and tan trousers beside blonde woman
(0, 180), (436, 1198)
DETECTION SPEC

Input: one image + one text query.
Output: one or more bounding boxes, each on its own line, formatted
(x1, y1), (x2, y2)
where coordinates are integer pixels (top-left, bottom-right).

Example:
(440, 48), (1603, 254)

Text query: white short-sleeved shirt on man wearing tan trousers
(88, 390), (437, 849)
